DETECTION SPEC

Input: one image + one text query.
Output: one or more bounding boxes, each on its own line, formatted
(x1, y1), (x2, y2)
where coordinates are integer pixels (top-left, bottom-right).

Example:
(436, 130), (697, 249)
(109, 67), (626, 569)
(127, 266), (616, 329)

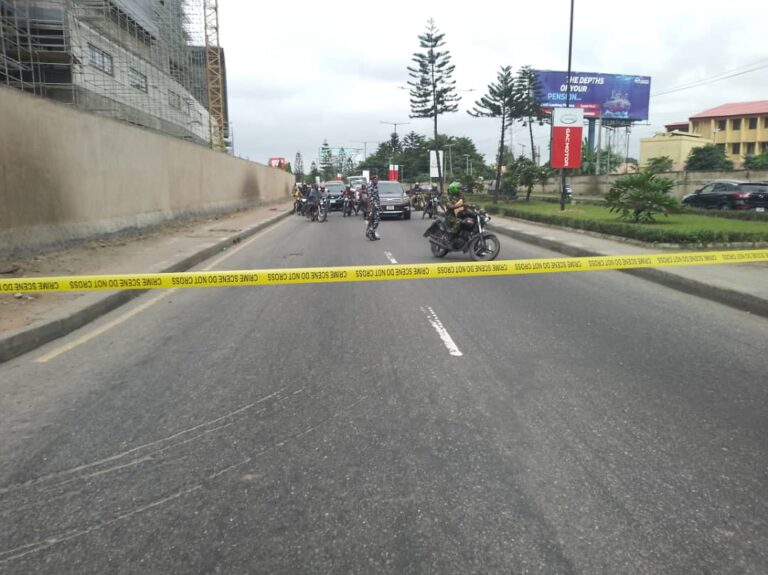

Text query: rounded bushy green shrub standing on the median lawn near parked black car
(605, 171), (681, 223)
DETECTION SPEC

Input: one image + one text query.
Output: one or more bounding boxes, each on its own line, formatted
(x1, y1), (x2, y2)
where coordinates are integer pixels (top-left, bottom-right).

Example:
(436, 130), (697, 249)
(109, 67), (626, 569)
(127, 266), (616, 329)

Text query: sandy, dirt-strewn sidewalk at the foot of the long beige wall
(0, 201), (293, 363)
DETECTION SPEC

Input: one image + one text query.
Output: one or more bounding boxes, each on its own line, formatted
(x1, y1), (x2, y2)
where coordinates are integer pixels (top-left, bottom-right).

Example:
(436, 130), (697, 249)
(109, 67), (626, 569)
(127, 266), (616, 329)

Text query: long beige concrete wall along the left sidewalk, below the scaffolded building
(0, 87), (293, 254)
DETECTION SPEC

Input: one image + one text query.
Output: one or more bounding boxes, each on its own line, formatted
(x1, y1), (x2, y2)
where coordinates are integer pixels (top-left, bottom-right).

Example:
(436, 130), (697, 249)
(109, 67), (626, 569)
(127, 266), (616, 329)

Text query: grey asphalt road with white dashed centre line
(0, 213), (768, 574)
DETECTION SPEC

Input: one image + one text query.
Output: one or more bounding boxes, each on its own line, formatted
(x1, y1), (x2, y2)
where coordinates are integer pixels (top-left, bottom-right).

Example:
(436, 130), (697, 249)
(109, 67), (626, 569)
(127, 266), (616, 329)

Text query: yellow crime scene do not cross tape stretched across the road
(0, 250), (768, 293)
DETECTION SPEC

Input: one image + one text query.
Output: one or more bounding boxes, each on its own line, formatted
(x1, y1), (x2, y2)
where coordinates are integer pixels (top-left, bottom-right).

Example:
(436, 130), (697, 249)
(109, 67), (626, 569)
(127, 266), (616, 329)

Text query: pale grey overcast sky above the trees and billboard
(219, 0), (768, 170)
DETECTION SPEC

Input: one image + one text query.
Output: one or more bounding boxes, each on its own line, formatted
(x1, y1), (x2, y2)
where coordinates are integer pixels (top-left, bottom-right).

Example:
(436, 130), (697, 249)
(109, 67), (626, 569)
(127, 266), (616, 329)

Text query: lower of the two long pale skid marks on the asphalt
(0, 394), (368, 565)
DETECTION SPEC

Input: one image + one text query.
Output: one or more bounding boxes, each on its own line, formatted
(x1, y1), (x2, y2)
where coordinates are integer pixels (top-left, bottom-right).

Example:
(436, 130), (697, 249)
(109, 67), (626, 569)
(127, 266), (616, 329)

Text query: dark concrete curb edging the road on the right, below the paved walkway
(488, 224), (768, 318)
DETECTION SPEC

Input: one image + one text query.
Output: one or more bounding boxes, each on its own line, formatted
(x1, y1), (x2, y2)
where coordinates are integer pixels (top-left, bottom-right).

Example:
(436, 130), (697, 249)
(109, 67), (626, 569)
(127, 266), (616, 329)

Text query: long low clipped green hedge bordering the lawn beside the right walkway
(496, 206), (768, 244)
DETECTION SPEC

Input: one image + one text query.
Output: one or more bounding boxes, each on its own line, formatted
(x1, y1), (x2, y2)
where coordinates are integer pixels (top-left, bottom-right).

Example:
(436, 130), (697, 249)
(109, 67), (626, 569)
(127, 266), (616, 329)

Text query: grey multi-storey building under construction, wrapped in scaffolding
(0, 0), (229, 147)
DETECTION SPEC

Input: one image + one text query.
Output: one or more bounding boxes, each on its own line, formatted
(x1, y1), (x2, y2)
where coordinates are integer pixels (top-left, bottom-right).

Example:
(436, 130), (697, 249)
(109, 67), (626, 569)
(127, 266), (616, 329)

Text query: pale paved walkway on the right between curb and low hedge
(488, 216), (768, 317)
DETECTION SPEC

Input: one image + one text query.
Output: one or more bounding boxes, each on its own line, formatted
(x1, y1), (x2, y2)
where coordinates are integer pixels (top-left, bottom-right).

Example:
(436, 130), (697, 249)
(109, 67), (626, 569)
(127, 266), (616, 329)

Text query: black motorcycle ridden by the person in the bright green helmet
(424, 207), (501, 262)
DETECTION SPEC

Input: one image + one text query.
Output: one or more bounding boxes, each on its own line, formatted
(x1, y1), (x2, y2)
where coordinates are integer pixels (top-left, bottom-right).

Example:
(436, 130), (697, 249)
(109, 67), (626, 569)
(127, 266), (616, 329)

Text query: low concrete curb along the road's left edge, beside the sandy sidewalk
(0, 211), (293, 363)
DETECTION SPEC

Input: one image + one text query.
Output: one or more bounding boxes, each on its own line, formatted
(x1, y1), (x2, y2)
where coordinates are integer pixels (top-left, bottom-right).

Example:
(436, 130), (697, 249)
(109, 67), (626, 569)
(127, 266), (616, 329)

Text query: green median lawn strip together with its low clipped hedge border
(468, 196), (768, 245)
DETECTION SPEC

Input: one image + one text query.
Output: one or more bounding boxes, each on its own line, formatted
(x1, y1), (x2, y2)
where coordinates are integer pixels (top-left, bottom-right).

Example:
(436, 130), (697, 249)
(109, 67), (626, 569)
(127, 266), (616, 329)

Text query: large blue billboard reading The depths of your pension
(536, 70), (651, 120)
